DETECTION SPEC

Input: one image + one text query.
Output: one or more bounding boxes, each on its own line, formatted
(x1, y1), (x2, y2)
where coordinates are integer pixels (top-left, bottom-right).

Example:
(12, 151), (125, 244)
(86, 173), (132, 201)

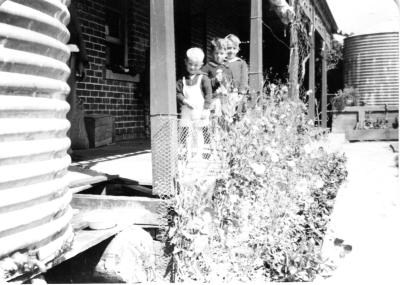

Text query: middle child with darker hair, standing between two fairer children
(202, 38), (233, 117)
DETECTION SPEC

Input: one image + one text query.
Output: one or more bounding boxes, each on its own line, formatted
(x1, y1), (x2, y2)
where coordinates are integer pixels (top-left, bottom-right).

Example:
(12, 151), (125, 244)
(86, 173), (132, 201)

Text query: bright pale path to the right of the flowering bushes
(323, 142), (400, 284)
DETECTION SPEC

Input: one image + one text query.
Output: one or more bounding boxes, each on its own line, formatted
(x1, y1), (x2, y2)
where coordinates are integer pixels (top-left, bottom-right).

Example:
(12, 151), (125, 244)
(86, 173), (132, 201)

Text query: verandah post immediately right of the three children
(249, 0), (263, 97)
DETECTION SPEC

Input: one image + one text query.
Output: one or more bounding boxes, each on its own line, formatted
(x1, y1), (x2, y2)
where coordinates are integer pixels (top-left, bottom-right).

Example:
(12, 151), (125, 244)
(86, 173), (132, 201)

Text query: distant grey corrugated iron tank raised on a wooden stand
(344, 32), (399, 106)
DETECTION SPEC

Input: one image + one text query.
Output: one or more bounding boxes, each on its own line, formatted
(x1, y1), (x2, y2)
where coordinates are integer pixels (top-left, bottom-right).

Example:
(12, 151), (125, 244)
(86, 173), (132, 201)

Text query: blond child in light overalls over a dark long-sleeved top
(176, 48), (212, 156)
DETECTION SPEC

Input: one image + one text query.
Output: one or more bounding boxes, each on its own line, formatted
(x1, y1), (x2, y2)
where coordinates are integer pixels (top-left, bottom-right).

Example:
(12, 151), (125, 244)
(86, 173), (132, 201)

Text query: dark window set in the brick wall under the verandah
(105, 0), (129, 73)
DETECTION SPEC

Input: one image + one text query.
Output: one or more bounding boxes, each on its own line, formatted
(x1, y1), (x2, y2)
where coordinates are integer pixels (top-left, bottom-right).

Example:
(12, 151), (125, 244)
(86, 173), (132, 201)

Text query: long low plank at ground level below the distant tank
(346, 128), (399, 141)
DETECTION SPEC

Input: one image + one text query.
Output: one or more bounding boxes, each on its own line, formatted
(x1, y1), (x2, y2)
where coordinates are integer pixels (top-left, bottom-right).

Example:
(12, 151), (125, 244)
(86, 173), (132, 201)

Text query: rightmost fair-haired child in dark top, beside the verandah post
(225, 34), (249, 94)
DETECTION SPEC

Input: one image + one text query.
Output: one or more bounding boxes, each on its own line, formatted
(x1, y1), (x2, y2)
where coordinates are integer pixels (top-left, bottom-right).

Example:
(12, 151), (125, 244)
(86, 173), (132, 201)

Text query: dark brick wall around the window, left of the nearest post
(75, 0), (149, 140)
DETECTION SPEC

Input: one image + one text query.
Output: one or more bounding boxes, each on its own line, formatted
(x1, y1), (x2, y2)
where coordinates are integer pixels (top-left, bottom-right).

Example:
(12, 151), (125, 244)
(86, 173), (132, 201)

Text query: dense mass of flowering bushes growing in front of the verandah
(167, 87), (347, 282)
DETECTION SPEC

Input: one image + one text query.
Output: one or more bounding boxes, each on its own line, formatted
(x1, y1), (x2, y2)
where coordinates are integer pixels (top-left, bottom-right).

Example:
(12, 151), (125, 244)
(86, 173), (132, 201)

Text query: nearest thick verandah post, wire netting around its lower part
(150, 0), (177, 195)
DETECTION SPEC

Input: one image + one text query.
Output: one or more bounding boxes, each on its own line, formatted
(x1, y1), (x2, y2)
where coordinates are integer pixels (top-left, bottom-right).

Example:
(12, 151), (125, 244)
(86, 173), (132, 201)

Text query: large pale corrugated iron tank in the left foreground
(0, 0), (73, 283)
